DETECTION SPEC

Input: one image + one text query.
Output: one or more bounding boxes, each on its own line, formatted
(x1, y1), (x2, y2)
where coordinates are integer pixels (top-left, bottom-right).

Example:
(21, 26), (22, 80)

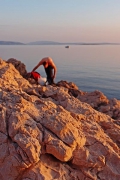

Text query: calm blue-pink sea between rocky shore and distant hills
(0, 45), (120, 99)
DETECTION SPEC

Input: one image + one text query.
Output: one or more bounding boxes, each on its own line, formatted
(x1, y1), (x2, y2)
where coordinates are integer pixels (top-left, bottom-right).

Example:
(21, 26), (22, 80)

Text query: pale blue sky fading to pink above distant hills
(0, 0), (120, 43)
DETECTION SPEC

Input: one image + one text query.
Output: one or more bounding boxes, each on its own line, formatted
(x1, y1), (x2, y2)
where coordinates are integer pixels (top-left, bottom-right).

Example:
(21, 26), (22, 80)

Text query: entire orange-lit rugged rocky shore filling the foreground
(0, 59), (120, 180)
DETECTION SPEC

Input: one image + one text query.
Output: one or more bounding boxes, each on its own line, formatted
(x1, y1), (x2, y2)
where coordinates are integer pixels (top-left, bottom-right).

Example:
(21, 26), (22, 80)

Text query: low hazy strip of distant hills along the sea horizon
(0, 41), (120, 45)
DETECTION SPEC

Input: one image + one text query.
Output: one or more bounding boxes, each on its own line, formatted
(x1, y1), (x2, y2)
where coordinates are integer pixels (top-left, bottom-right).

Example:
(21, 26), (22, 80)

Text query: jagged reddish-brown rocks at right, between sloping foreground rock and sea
(57, 81), (120, 120)
